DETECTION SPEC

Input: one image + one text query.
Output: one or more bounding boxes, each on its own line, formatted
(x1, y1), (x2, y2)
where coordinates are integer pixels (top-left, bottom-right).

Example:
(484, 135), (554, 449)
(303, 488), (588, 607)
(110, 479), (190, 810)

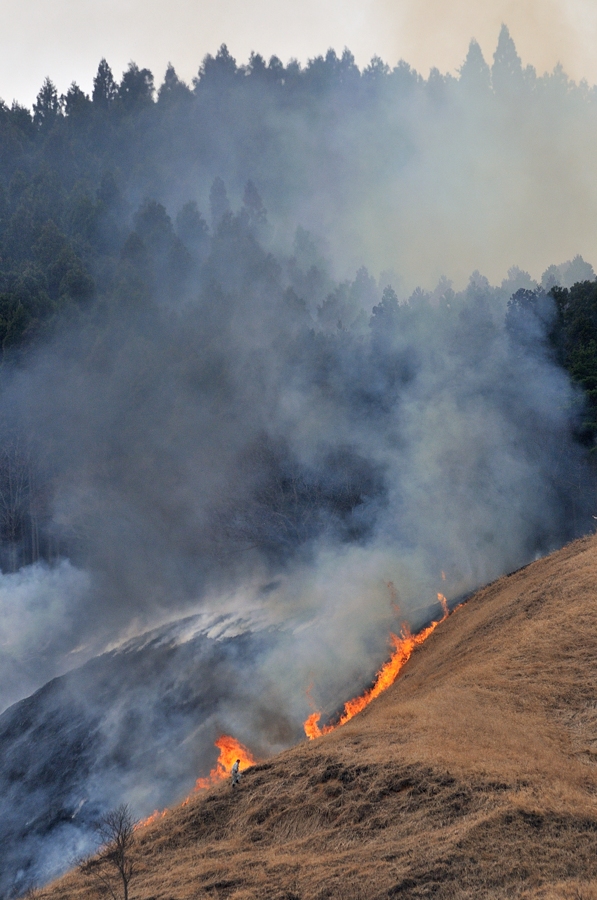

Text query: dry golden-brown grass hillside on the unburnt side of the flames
(40, 537), (597, 900)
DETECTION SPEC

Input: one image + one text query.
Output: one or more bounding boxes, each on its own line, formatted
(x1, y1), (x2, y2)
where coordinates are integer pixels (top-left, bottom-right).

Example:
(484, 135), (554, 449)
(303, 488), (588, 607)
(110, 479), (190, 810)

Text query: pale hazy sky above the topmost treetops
(0, 0), (597, 105)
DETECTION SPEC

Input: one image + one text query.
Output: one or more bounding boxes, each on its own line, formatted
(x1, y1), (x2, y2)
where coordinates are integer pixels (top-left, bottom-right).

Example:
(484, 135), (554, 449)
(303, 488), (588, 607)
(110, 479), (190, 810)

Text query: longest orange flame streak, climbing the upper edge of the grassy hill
(303, 594), (450, 741)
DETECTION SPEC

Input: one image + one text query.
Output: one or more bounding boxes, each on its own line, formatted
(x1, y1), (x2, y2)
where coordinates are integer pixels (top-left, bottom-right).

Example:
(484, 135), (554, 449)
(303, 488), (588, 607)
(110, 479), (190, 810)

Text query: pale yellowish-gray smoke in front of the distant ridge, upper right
(137, 29), (597, 299)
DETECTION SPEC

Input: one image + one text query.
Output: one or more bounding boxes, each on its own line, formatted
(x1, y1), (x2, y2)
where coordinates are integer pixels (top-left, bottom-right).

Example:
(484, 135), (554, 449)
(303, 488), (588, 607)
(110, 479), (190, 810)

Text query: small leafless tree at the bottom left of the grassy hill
(80, 803), (136, 900)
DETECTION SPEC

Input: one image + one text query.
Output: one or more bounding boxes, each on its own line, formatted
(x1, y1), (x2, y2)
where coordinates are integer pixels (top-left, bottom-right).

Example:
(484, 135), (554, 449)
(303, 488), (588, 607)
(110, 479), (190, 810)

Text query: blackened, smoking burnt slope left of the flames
(0, 614), (290, 898)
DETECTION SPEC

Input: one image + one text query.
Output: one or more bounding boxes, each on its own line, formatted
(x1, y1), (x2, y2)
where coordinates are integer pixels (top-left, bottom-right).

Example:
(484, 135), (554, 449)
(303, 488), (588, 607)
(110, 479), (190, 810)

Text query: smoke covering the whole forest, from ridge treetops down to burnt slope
(0, 29), (597, 896)
